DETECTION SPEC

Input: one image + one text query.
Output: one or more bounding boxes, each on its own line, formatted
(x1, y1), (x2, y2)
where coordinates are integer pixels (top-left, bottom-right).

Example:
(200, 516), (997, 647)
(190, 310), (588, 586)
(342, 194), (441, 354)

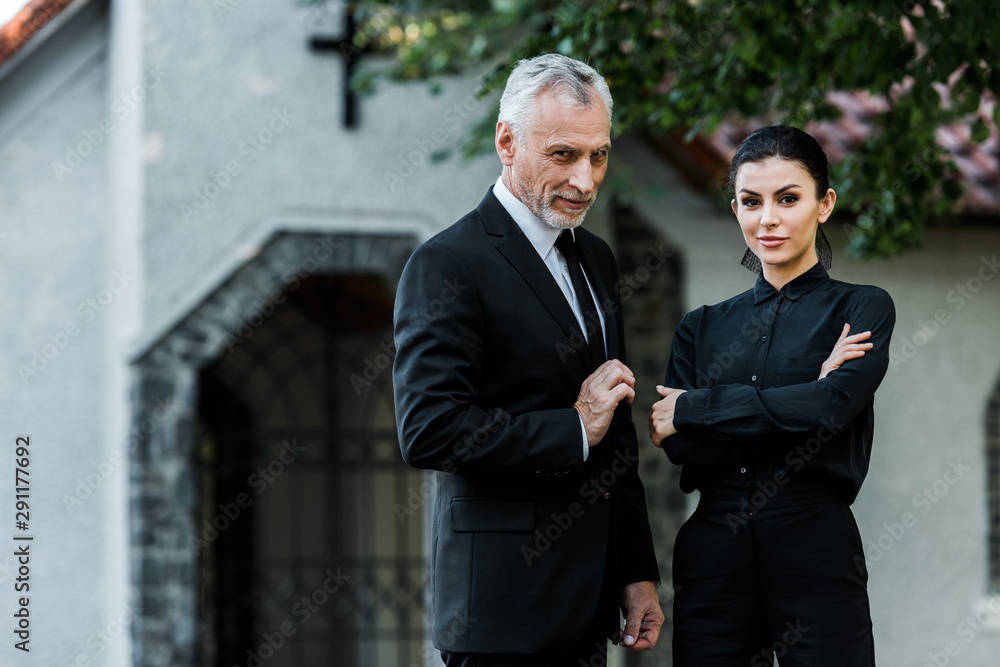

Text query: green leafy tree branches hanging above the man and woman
(322, 0), (1000, 257)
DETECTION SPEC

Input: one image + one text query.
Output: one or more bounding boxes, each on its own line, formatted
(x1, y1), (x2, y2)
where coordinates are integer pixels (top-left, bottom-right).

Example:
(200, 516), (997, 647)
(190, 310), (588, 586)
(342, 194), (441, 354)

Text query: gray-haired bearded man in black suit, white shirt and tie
(393, 54), (663, 667)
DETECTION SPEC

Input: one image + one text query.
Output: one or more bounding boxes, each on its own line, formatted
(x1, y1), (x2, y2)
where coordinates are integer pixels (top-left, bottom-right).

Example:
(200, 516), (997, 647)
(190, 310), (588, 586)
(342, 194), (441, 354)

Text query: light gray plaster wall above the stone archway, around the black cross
(138, 0), (499, 344)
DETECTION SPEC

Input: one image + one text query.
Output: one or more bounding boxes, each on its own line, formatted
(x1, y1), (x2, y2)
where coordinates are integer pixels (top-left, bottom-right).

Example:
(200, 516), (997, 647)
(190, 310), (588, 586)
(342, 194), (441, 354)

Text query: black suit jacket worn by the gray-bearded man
(393, 189), (659, 653)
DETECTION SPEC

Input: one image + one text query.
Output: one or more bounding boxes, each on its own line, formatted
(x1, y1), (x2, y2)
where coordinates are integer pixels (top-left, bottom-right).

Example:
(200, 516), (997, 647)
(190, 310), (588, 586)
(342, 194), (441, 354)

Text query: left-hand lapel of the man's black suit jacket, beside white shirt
(478, 188), (593, 368)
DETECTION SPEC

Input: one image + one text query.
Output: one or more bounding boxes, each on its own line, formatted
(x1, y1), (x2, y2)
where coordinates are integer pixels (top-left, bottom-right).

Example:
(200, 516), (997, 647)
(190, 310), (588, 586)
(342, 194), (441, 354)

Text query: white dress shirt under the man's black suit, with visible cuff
(493, 175), (608, 461)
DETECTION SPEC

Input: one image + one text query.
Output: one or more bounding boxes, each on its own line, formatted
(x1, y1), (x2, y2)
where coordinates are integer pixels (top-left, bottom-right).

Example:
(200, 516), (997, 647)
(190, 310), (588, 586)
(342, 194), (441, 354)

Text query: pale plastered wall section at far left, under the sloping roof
(0, 2), (139, 665)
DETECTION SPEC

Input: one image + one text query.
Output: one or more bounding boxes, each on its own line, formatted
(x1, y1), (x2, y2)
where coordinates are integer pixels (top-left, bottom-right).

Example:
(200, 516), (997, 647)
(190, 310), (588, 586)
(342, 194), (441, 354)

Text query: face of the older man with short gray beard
(497, 91), (611, 229)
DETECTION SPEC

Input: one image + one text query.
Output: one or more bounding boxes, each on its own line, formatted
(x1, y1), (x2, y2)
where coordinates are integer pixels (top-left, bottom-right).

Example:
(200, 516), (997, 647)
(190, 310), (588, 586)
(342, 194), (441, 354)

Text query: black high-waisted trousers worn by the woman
(673, 493), (875, 667)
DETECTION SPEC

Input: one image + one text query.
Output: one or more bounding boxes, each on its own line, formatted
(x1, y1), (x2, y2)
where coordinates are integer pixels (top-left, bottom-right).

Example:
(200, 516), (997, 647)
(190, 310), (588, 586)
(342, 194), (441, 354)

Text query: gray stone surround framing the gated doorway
(129, 232), (418, 667)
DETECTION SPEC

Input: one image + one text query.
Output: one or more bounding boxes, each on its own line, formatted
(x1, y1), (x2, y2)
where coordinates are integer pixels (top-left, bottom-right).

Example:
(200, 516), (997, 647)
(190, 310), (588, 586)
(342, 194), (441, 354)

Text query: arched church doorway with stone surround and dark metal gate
(132, 234), (426, 667)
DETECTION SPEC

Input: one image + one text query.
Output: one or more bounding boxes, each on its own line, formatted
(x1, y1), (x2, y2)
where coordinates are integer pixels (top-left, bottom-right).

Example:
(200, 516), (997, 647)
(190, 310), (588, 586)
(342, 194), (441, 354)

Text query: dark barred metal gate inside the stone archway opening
(194, 275), (430, 667)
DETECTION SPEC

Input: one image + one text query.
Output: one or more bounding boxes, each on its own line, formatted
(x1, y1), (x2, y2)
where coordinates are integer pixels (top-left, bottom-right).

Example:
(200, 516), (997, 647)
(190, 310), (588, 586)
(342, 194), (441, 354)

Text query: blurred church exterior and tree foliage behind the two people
(0, 0), (1000, 667)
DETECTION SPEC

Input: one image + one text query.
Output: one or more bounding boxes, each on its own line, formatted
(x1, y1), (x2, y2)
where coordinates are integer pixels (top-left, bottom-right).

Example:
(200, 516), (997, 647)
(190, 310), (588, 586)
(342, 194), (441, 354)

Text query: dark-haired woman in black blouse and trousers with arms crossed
(649, 127), (895, 667)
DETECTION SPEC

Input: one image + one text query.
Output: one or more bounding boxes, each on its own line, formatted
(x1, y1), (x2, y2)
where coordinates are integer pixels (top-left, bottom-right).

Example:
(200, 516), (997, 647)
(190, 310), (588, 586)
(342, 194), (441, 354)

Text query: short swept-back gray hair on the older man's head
(497, 53), (615, 138)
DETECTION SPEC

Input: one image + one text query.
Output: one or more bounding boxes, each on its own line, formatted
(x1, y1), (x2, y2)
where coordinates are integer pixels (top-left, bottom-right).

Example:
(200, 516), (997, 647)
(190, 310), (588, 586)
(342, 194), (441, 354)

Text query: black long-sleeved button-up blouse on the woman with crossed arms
(663, 264), (896, 503)
